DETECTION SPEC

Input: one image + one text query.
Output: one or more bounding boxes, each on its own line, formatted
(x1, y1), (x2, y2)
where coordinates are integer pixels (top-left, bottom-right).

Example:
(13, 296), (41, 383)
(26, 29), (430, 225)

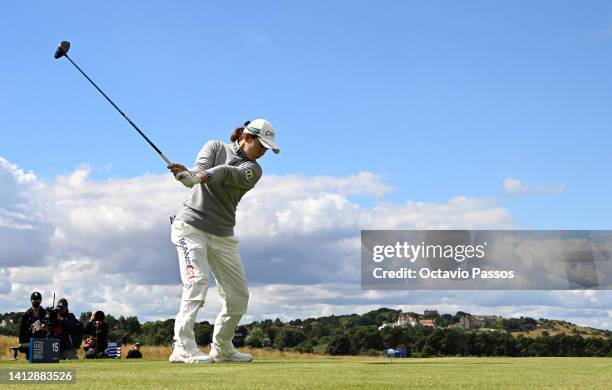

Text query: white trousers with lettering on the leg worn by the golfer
(171, 220), (249, 353)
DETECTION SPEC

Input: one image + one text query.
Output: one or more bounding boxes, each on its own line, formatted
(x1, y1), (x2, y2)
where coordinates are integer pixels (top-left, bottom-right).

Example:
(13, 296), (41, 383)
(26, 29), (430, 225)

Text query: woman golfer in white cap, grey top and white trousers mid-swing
(168, 119), (279, 363)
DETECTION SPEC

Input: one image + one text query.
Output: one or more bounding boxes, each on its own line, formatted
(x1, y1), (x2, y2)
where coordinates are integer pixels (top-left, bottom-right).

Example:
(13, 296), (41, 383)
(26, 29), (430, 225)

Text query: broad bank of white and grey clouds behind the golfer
(0, 159), (610, 326)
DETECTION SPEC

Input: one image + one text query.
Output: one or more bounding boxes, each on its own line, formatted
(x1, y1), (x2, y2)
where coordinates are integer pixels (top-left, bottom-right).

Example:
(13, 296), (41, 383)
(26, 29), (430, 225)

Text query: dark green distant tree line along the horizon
(0, 308), (612, 357)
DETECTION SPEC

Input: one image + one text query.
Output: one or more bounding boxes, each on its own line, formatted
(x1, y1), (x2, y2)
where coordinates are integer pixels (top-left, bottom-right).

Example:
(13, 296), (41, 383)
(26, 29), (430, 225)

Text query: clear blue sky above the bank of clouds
(0, 1), (612, 328)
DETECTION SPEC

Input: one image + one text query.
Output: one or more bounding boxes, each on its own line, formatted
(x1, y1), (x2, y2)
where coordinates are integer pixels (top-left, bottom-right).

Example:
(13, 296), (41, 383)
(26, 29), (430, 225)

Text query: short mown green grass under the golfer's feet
(0, 357), (612, 389)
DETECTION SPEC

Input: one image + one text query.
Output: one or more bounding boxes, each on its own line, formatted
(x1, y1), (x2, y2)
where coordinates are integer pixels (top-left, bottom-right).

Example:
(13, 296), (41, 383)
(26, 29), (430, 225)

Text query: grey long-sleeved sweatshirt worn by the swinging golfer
(176, 141), (262, 236)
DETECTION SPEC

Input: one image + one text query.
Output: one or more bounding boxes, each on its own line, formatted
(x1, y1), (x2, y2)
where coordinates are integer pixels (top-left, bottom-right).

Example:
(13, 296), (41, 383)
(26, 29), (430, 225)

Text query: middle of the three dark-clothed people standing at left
(49, 298), (83, 360)
